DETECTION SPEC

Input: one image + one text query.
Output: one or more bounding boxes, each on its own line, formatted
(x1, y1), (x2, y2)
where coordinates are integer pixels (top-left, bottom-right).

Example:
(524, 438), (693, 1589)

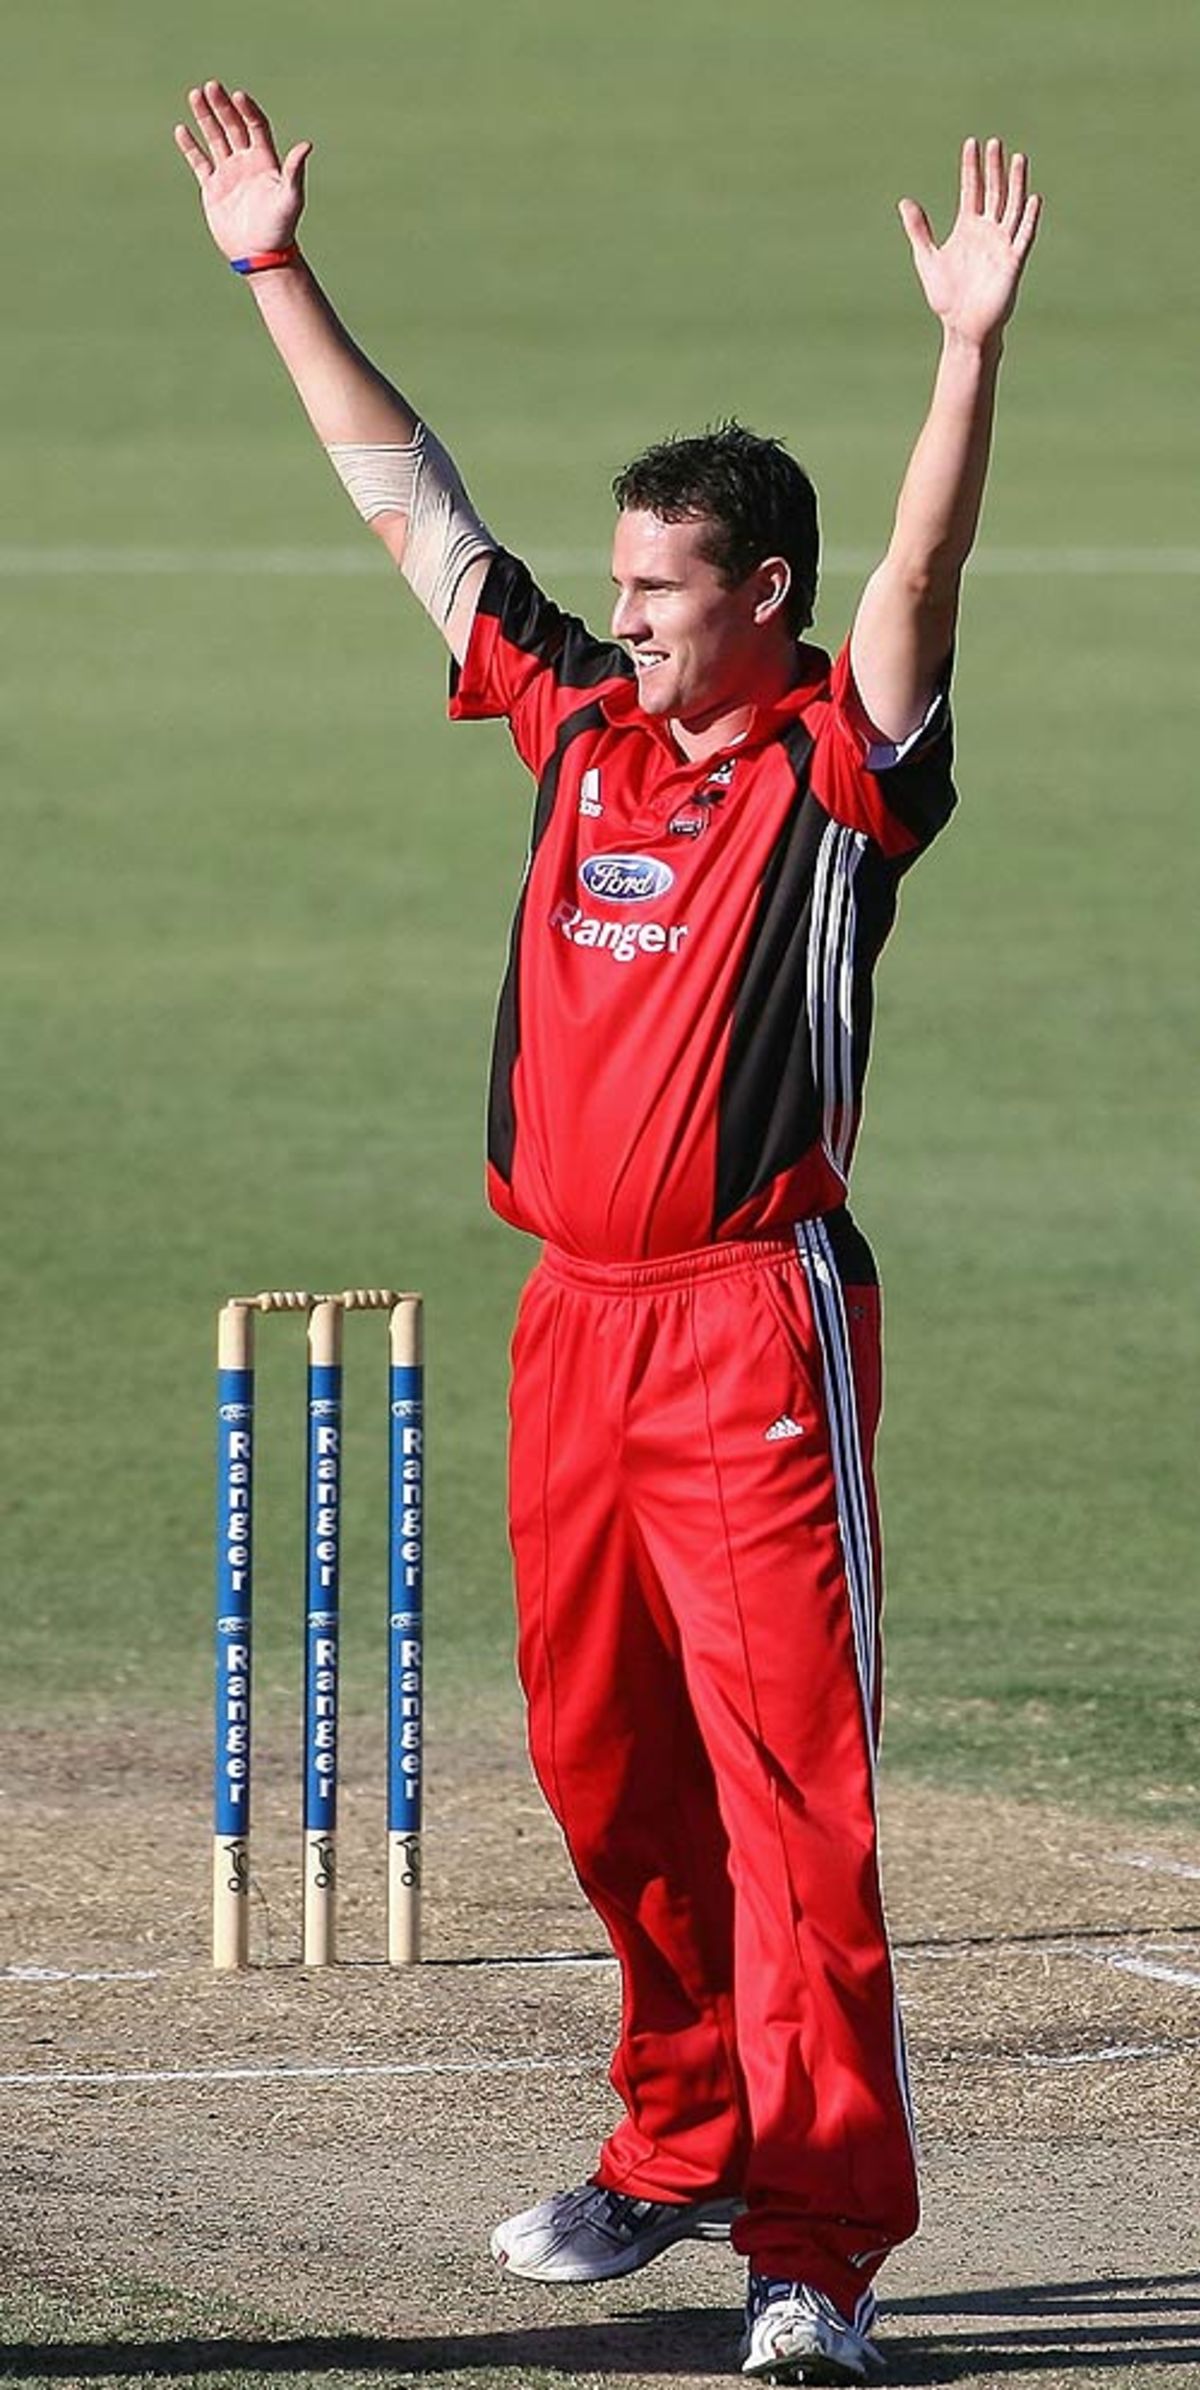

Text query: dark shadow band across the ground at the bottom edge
(0, 2273), (1200, 2390)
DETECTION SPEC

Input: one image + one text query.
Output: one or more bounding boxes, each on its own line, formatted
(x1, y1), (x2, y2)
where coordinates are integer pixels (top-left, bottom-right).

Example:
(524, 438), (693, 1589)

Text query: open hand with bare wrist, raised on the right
(899, 141), (1042, 342)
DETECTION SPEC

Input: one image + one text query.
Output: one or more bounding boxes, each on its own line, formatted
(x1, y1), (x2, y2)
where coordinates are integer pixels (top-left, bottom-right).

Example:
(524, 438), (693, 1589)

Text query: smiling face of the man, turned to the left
(612, 509), (786, 727)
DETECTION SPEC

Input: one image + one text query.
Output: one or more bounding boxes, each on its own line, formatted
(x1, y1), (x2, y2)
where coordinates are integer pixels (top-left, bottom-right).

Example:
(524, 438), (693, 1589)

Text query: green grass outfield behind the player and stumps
(0, 0), (1200, 1814)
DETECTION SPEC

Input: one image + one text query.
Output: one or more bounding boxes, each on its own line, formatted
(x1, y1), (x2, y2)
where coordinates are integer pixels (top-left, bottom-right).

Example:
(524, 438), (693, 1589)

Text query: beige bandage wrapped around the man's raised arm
(325, 423), (497, 652)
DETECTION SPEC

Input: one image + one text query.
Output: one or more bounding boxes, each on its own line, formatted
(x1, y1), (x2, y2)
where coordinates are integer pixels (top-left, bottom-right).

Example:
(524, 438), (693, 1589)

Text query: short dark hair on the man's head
(612, 416), (820, 636)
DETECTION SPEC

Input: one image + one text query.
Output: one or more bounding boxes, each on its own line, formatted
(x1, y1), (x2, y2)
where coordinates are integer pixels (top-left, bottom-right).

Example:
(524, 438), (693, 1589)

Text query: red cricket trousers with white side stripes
(512, 1214), (918, 2314)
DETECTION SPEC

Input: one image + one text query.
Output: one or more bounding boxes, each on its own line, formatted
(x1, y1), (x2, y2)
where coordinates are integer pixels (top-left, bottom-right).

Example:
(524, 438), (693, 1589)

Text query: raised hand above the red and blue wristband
(175, 84), (313, 258)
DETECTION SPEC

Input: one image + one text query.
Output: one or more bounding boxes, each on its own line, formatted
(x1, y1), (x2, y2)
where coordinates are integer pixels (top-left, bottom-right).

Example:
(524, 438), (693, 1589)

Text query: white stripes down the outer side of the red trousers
(796, 1219), (916, 2156)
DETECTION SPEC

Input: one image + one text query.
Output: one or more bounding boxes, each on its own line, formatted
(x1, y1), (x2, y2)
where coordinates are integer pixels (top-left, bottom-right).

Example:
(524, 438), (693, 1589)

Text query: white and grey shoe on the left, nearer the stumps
(490, 2182), (741, 2282)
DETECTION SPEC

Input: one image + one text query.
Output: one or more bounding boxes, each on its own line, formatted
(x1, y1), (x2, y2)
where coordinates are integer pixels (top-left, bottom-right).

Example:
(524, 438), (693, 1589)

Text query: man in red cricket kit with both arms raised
(177, 84), (1040, 2383)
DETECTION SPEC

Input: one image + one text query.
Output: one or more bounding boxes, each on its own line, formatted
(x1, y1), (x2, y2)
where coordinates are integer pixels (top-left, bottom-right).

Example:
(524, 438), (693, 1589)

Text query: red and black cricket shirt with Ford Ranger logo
(449, 552), (956, 1262)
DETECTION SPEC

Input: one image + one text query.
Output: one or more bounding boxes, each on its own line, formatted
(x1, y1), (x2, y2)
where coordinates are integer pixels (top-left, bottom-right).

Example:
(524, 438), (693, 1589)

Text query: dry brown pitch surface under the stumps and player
(0, 1711), (1200, 2390)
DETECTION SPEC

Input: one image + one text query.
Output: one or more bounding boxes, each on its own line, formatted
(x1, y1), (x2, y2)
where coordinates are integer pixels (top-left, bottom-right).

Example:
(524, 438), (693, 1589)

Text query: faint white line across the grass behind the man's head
(0, 545), (1200, 581)
